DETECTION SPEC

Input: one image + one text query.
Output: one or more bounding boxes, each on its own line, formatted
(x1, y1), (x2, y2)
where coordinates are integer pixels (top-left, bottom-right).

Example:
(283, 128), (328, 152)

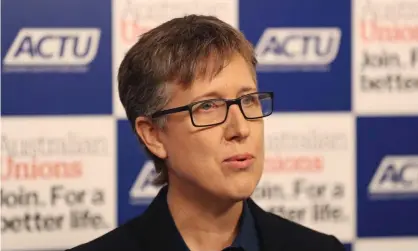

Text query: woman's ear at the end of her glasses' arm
(135, 117), (167, 159)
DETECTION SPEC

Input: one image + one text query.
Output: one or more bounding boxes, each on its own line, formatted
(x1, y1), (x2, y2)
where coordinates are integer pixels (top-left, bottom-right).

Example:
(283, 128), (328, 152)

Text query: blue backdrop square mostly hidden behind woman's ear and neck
(117, 120), (158, 225)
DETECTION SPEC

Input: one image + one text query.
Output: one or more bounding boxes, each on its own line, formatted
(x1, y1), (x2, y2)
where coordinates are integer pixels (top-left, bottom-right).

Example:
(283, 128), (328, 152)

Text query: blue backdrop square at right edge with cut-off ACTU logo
(357, 116), (418, 237)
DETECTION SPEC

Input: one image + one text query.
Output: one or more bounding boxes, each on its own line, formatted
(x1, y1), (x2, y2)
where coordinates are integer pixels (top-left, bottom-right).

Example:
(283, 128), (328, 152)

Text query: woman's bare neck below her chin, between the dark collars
(167, 184), (243, 250)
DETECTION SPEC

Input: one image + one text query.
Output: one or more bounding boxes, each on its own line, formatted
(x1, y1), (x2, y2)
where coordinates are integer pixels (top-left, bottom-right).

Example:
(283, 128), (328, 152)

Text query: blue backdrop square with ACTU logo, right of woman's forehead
(239, 0), (351, 112)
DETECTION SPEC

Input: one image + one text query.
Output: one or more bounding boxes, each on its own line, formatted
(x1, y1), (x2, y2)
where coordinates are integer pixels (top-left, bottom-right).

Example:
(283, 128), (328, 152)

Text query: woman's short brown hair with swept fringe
(118, 15), (257, 185)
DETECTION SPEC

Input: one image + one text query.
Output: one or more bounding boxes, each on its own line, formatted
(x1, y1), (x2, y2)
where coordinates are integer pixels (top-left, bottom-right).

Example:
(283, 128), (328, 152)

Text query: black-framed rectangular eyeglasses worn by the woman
(151, 92), (273, 127)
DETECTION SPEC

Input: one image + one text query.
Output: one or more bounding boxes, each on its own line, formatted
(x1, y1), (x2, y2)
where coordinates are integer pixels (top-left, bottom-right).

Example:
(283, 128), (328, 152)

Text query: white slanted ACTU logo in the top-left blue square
(3, 28), (101, 72)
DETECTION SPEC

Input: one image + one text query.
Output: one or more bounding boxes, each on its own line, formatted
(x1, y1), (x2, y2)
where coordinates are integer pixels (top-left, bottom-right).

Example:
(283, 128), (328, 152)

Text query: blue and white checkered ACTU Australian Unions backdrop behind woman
(1, 0), (418, 251)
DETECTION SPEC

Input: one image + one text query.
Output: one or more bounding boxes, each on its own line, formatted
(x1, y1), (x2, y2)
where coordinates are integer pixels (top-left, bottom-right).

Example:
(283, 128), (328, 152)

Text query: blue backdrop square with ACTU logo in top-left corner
(1, 0), (112, 115)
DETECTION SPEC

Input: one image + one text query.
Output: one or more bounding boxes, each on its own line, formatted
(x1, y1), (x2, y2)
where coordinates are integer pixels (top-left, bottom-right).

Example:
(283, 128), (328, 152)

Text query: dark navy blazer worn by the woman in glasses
(68, 186), (345, 251)
